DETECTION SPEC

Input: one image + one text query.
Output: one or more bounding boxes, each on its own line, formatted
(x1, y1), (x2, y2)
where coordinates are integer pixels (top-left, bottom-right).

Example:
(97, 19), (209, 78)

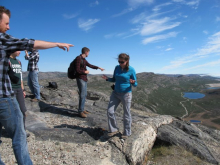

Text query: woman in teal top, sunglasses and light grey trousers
(102, 53), (137, 139)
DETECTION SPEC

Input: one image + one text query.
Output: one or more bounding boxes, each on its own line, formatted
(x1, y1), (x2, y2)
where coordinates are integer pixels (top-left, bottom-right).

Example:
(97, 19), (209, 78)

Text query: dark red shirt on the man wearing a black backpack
(76, 55), (99, 81)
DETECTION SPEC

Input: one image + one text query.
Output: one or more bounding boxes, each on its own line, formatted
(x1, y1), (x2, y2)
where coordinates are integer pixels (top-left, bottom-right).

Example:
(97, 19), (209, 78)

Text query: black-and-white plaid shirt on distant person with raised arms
(25, 50), (40, 71)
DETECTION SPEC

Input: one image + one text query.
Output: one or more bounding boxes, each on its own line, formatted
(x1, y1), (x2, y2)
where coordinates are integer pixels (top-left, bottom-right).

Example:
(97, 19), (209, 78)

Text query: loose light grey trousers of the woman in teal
(107, 91), (132, 136)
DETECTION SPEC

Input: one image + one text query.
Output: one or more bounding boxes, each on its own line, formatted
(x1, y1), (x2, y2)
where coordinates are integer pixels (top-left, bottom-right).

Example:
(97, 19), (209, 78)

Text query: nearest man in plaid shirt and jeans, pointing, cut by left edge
(0, 6), (73, 165)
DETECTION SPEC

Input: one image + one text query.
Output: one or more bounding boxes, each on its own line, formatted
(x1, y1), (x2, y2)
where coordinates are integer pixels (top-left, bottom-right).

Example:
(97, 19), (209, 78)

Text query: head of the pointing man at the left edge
(0, 6), (11, 33)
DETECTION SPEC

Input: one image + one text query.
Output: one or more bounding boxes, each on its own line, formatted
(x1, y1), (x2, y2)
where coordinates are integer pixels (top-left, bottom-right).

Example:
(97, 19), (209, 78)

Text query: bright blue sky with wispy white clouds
(1, 0), (220, 76)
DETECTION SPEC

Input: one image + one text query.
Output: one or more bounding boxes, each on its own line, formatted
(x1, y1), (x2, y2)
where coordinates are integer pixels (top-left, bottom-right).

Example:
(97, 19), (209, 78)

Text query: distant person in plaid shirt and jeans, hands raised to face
(25, 49), (40, 102)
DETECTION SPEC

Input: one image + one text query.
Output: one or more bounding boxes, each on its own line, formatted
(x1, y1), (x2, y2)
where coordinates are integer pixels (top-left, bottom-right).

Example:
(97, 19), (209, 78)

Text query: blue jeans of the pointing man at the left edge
(0, 97), (33, 165)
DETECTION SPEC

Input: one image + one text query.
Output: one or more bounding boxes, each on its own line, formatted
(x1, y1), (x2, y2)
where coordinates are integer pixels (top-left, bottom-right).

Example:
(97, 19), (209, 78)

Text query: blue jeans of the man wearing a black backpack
(76, 78), (87, 113)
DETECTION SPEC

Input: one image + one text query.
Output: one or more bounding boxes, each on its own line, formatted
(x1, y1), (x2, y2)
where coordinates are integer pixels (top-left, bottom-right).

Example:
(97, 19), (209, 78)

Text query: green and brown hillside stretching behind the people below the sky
(24, 72), (220, 129)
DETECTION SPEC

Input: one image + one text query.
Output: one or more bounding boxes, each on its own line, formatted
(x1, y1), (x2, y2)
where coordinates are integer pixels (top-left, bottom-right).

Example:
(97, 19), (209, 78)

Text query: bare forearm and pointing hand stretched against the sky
(34, 40), (74, 51)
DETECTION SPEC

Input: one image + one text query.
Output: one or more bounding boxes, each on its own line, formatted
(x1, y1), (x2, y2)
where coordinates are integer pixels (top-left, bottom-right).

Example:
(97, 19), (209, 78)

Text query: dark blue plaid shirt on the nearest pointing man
(0, 33), (34, 98)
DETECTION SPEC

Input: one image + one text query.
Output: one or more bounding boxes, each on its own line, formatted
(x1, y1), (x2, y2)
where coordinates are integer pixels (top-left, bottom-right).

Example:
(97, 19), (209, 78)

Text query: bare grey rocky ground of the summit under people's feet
(0, 79), (220, 165)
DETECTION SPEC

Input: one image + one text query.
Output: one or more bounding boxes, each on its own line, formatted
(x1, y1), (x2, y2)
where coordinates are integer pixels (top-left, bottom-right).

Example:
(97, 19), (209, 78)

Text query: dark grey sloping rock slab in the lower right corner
(157, 120), (220, 164)
